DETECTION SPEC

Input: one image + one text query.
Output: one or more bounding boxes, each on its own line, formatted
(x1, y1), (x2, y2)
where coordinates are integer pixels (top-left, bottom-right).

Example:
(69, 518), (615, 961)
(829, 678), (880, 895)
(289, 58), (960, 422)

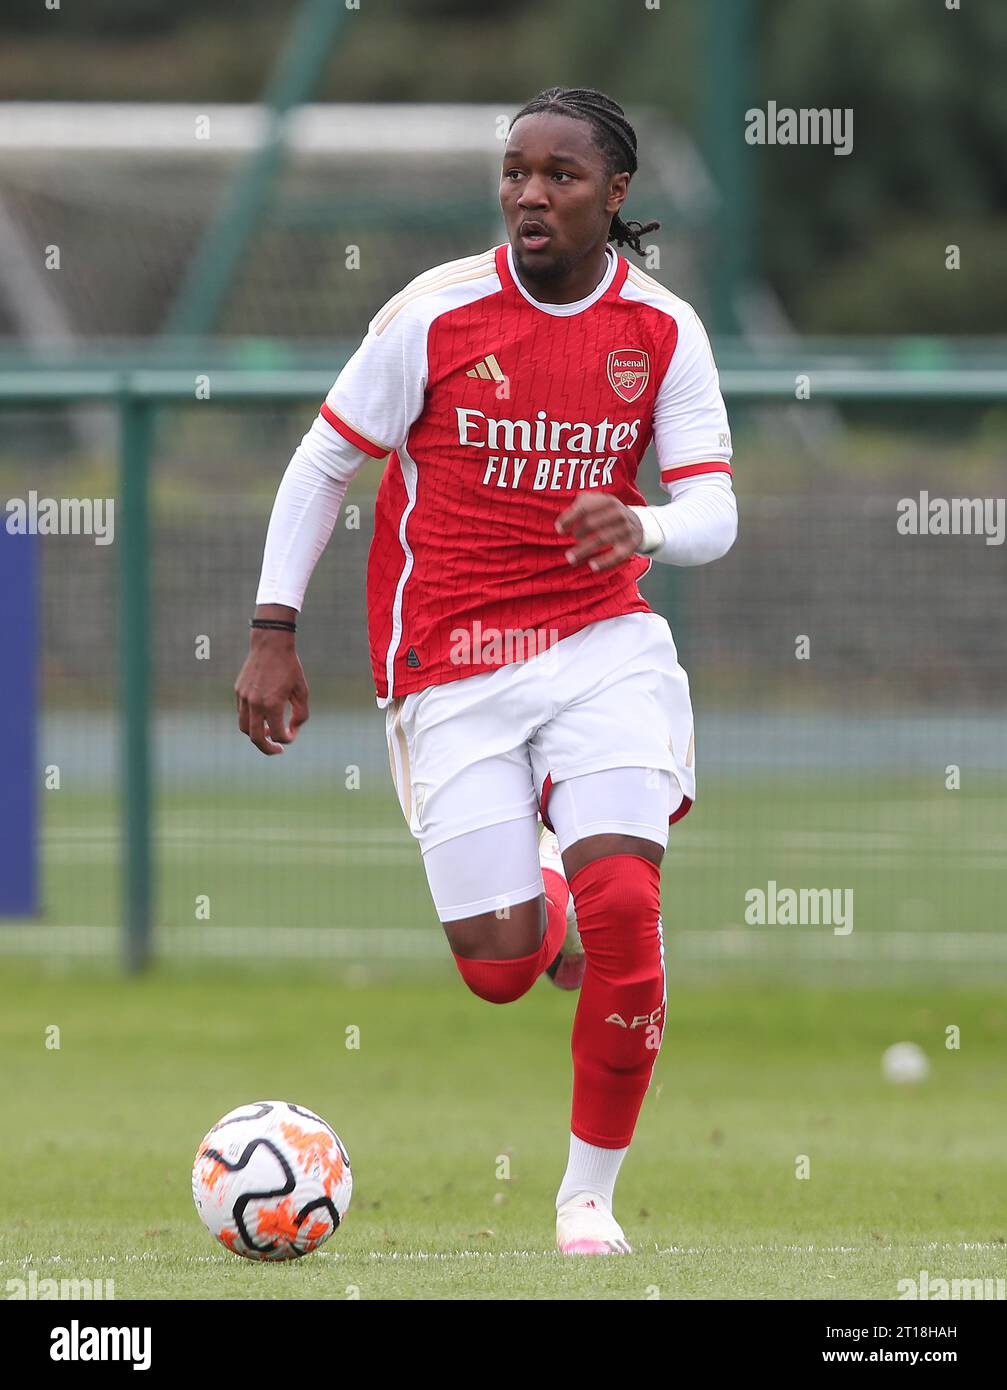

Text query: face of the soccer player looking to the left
(499, 111), (630, 281)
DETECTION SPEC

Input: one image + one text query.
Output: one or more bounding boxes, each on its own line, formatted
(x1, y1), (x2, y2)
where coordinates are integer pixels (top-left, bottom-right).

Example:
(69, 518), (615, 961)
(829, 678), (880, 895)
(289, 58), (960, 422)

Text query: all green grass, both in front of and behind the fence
(0, 770), (1007, 1300)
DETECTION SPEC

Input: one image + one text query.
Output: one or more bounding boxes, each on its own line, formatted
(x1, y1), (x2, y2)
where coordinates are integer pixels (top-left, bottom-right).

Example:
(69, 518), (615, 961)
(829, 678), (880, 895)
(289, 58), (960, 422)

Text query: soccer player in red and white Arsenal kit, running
(235, 88), (737, 1254)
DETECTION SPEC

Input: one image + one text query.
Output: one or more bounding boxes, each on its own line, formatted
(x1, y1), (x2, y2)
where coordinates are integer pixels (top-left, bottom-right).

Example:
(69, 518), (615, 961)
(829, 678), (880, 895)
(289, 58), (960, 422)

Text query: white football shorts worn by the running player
(385, 613), (695, 855)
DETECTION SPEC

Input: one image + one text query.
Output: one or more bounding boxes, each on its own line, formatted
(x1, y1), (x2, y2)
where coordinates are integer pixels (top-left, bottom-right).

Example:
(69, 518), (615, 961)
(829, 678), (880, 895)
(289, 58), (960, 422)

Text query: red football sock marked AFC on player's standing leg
(570, 855), (666, 1148)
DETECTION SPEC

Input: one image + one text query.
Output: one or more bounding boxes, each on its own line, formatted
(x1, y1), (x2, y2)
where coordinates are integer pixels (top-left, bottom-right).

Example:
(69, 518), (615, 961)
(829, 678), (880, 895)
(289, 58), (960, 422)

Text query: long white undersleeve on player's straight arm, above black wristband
(256, 416), (367, 612)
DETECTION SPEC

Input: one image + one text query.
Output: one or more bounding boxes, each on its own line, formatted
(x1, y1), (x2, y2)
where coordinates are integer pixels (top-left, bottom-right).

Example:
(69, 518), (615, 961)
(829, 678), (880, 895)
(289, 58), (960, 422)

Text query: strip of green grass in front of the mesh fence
(0, 962), (1007, 1300)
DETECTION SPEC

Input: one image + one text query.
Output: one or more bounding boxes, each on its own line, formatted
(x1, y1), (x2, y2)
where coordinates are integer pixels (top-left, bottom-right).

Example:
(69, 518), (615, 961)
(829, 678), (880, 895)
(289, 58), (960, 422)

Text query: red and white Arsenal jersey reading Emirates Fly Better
(321, 245), (732, 706)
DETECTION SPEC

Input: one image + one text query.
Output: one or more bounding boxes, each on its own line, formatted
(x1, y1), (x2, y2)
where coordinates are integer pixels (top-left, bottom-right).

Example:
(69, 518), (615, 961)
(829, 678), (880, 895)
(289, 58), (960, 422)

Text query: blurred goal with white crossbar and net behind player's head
(0, 103), (714, 346)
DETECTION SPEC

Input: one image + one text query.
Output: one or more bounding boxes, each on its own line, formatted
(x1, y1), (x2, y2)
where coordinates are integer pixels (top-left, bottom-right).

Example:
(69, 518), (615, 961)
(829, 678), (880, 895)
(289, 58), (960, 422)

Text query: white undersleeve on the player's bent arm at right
(630, 473), (737, 564)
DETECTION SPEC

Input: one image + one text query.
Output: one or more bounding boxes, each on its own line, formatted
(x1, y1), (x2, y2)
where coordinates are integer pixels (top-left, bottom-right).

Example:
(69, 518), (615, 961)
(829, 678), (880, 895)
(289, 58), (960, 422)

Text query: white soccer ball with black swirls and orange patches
(192, 1101), (353, 1259)
